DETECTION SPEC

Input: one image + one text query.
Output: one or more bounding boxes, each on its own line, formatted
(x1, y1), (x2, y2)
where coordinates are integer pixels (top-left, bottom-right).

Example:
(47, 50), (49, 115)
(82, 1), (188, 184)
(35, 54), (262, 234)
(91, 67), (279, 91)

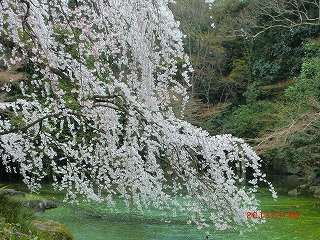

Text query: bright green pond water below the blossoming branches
(33, 189), (320, 240)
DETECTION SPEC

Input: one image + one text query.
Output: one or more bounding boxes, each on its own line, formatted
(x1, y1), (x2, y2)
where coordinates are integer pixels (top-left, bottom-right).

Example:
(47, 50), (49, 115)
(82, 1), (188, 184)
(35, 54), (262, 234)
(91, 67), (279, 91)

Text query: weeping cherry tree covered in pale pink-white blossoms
(0, 0), (275, 229)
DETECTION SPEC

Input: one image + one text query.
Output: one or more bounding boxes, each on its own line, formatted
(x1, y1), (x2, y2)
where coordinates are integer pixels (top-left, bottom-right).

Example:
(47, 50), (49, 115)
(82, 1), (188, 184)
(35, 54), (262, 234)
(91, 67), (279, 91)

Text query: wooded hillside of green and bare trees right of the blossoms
(172, 0), (320, 182)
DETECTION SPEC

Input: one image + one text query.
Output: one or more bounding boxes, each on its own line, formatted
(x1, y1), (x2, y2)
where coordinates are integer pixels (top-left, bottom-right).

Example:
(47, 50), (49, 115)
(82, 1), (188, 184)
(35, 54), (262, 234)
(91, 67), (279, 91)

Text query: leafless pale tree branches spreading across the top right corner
(214, 0), (320, 37)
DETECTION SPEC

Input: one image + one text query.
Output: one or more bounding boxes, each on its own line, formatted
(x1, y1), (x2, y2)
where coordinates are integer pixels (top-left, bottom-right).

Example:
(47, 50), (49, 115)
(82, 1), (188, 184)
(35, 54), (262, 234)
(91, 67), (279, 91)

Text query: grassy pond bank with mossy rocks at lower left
(0, 187), (73, 240)
